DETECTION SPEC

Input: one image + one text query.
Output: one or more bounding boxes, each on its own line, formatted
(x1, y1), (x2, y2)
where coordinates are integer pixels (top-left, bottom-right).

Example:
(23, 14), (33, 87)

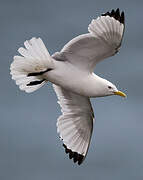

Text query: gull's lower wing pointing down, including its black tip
(53, 85), (94, 165)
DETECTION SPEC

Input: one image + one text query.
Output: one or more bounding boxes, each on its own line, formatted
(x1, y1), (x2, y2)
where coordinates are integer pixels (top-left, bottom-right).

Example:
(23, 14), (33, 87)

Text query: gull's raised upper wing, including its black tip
(56, 9), (124, 72)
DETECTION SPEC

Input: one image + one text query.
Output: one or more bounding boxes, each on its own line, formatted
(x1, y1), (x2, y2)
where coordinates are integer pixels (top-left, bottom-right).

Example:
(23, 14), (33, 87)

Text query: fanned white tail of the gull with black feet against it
(10, 38), (53, 93)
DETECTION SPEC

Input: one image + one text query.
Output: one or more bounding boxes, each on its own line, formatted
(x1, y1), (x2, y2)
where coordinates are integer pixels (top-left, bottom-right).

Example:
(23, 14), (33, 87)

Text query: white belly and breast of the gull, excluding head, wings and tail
(45, 61), (93, 97)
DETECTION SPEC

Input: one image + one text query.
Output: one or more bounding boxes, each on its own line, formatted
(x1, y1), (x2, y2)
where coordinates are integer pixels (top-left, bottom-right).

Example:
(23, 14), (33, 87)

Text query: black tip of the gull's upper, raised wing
(102, 8), (125, 24)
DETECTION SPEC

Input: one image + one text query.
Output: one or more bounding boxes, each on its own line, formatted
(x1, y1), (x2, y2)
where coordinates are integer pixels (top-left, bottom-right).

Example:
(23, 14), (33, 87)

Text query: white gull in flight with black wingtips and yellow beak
(10, 8), (126, 165)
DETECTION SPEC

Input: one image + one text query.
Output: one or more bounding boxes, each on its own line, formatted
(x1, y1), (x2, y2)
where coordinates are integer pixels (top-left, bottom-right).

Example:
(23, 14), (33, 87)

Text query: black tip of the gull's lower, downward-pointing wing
(63, 144), (84, 165)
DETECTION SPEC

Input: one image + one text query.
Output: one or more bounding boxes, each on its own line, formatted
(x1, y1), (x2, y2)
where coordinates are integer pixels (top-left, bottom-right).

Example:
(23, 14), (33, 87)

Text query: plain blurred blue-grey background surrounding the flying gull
(0, 0), (143, 180)
